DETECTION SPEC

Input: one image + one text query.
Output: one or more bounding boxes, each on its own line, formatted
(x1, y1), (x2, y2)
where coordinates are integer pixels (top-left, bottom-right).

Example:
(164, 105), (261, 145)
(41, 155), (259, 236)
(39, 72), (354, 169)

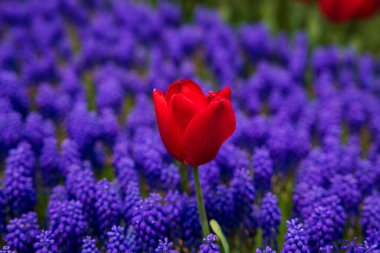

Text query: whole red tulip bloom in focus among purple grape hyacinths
(153, 79), (236, 166)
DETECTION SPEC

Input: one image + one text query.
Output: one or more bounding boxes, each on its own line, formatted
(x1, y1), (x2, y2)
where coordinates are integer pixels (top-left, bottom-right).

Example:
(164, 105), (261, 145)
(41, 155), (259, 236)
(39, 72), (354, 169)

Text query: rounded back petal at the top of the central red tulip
(166, 79), (207, 108)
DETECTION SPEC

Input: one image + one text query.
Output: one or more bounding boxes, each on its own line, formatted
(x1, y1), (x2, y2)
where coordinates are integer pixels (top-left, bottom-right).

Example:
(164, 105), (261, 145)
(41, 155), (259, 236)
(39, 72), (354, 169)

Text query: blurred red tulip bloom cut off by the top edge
(319, 0), (380, 23)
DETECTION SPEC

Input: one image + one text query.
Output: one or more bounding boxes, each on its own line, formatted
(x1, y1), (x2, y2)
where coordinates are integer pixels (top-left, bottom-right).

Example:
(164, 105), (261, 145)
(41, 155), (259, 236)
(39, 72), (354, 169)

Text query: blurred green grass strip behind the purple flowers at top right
(165, 0), (380, 54)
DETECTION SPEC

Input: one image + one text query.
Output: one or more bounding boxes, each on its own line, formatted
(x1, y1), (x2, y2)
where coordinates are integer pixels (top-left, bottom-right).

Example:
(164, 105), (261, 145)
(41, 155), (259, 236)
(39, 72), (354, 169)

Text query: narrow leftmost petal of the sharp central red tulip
(153, 90), (178, 159)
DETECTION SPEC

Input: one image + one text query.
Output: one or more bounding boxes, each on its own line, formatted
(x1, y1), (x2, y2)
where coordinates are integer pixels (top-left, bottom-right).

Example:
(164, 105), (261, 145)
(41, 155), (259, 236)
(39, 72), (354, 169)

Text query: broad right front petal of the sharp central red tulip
(184, 99), (236, 166)
